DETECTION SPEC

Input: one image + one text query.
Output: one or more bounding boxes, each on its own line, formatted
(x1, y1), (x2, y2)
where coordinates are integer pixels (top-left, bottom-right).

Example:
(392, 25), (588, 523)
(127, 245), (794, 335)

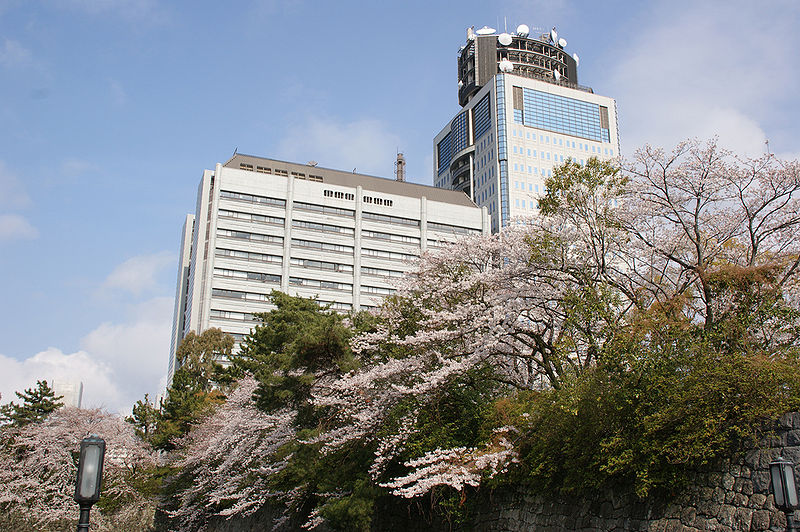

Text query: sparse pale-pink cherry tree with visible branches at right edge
(617, 141), (800, 329)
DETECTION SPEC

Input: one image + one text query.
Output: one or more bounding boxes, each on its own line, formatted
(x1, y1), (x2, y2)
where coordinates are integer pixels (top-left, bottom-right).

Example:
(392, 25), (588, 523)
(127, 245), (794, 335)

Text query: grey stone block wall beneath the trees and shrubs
(197, 413), (800, 532)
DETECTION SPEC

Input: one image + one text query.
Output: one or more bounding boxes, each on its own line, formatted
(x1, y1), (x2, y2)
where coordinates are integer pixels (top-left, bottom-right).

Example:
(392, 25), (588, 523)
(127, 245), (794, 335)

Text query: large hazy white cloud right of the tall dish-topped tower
(607, 0), (800, 155)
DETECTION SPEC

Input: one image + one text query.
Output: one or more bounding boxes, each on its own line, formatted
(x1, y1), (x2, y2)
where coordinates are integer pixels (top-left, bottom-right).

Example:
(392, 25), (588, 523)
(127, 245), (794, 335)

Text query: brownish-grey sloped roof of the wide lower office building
(222, 153), (476, 207)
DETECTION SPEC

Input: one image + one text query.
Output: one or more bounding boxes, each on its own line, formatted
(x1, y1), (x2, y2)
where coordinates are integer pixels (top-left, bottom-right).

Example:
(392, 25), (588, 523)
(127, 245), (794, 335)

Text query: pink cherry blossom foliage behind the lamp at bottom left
(0, 408), (155, 530)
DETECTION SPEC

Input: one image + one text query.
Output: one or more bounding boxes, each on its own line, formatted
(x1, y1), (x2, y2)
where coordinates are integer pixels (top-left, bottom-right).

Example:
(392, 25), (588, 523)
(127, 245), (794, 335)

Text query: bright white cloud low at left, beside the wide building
(0, 297), (172, 413)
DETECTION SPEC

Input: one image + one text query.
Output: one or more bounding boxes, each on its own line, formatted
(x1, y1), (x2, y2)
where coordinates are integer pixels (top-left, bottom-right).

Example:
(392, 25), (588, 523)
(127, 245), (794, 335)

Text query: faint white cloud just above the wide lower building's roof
(279, 117), (401, 177)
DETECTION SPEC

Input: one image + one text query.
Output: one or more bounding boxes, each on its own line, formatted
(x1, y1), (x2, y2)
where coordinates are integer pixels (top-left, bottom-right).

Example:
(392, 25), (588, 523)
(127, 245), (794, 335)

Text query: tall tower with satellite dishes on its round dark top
(433, 25), (619, 232)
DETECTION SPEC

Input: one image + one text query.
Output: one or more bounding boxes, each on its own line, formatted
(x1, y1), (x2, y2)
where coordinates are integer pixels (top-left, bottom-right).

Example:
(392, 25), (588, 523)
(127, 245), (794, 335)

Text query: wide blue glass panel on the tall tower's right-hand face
(514, 87), (611, 142)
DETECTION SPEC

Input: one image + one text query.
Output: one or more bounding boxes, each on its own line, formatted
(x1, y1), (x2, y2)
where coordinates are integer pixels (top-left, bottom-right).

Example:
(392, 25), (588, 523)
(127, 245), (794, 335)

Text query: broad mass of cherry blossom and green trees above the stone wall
(158, 141), (800, 530)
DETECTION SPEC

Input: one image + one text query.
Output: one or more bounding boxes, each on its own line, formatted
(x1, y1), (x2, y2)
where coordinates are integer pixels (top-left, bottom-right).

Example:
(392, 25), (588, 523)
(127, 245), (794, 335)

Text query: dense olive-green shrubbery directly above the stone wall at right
(516, 302), (800, 497)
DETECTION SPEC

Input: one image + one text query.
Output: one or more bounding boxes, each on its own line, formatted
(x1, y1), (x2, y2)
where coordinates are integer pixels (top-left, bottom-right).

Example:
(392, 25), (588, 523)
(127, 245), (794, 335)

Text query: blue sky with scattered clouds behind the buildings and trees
(0, 0), (800, 412)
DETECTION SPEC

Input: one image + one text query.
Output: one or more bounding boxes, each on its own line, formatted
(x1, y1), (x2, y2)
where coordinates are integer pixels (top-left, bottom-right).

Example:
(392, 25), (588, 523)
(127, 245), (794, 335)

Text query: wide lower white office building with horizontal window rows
(168, 154), (489, 385)
